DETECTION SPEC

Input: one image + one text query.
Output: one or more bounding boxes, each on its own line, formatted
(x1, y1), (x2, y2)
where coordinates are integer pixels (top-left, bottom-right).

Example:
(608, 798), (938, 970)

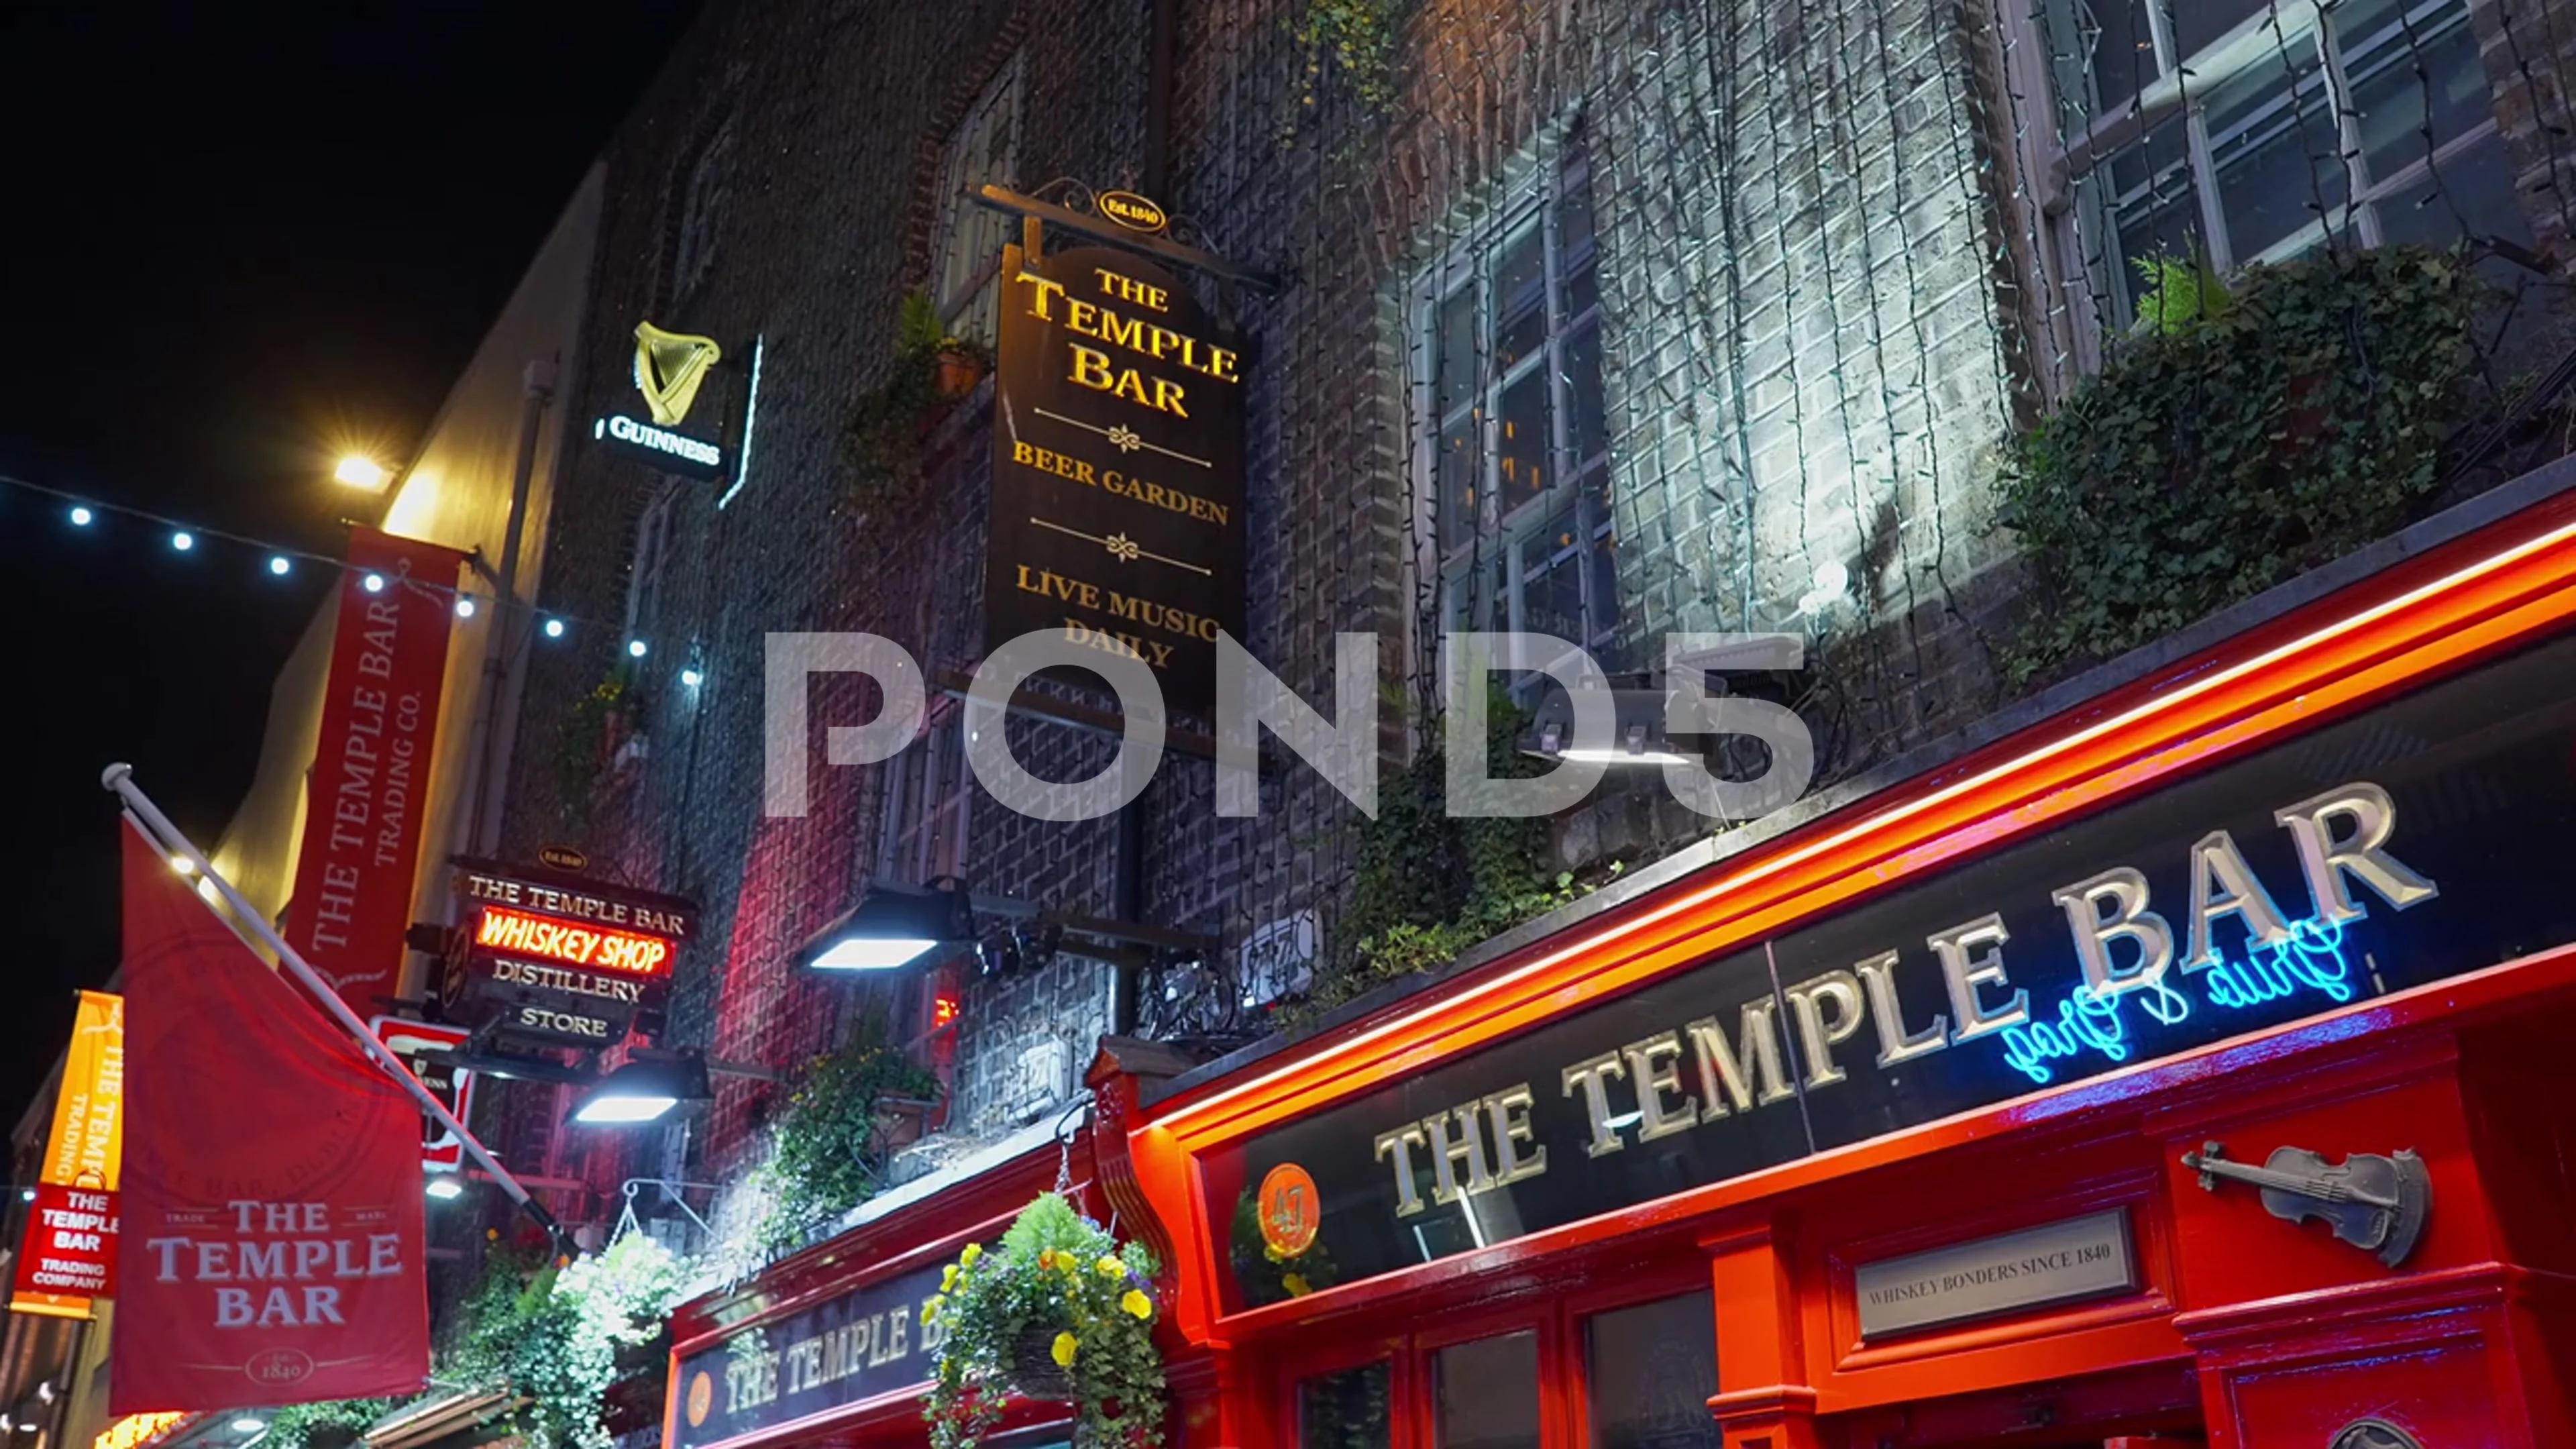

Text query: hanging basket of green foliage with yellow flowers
(922, 1194), (1165, 1449)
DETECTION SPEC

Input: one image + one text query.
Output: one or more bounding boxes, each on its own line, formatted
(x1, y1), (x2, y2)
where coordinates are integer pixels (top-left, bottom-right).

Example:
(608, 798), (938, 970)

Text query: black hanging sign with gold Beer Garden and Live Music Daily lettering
(984, 248), (1244, 712)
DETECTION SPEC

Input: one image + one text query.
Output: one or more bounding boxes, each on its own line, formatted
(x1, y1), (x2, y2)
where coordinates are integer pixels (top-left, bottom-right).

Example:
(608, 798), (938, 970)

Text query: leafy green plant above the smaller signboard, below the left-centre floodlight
(757, 1024), (941, 1253)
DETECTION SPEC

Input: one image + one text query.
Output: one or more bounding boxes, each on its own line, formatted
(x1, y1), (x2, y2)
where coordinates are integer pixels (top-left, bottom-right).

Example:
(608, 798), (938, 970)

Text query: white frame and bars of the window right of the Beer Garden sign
(1407, 142), (1620, 688)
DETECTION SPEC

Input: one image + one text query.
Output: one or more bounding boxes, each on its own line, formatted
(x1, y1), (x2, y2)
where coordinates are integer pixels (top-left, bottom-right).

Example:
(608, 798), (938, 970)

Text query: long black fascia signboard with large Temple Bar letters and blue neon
(1203, 634), (2576, 1307)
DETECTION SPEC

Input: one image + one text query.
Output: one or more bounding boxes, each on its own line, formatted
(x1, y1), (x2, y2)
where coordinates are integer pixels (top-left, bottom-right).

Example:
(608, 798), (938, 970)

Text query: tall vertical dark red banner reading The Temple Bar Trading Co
(286, 529), (464, 1016)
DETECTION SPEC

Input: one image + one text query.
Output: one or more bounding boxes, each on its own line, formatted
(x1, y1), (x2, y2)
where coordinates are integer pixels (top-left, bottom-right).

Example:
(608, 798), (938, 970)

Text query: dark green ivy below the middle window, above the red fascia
(1306, 688), (1620, 1011)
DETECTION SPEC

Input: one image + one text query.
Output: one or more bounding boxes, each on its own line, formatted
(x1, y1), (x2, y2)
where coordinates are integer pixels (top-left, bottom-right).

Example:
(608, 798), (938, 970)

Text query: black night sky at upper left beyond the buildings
(0, 0), (696, 1124)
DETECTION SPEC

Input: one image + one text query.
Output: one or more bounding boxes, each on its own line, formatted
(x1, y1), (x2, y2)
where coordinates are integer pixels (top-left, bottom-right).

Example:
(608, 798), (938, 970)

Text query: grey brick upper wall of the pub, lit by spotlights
(492, 0), (2571, 1242)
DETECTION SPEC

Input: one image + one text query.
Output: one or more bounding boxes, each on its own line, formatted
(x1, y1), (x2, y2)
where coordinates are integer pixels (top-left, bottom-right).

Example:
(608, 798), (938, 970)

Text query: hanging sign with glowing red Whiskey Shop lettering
(443, 859), (698, 1049)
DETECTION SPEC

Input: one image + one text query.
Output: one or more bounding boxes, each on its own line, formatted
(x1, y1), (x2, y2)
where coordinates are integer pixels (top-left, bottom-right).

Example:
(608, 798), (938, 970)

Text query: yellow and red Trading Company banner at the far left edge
(8, 990), (126, 1318)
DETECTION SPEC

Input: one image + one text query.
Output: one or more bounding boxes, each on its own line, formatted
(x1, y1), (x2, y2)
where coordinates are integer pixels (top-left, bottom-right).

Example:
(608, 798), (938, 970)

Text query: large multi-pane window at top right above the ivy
(2040, 0), (2527, 327)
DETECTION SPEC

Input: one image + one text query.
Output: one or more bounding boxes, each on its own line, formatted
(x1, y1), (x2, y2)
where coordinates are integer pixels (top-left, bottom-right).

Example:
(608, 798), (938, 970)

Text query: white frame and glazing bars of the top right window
(2012, 0), (2502, 332)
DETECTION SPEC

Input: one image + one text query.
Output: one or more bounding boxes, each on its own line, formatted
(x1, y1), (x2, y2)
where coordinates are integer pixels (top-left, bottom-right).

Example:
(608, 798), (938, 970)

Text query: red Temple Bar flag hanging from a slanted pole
(108, 825), (430, 1413)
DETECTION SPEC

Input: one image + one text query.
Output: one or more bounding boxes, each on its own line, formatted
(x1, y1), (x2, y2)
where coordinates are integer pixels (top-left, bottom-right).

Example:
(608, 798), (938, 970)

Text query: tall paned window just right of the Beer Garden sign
(1414, 142), (1618, 665)
